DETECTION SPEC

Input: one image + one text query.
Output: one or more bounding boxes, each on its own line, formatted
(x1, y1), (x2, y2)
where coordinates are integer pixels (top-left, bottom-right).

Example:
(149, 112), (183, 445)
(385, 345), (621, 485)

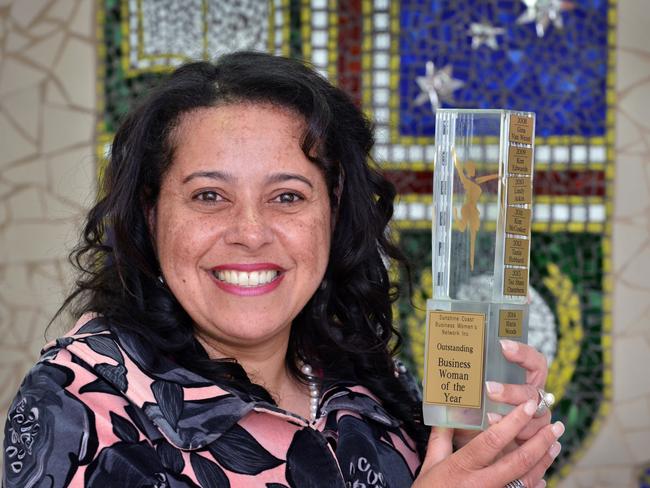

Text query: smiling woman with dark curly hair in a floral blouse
(5, 53), (561, 488)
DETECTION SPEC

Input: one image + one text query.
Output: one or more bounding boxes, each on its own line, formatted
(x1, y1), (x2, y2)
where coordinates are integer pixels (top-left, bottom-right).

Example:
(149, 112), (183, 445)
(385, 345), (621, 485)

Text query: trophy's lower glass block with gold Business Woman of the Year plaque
(423, 299), (528, 430)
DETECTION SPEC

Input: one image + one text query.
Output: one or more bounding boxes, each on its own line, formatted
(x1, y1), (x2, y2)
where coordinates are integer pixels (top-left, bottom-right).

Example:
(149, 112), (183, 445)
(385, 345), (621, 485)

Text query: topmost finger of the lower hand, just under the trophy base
(455, 400), (537, 471)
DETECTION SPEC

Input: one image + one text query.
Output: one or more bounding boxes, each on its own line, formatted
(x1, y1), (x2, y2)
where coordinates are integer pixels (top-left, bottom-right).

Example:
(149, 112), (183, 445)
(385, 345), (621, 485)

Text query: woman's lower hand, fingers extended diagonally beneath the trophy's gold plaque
(413, 400), (564, 488)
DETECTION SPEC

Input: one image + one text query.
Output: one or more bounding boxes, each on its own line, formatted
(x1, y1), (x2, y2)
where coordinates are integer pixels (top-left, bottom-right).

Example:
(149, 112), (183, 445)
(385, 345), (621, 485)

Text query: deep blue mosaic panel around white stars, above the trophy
(399, 0), (608, 137)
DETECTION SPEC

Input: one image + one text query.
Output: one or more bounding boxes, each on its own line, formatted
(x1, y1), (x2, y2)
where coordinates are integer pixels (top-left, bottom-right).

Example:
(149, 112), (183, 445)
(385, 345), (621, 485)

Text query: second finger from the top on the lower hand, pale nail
(486, 422), (564, 486)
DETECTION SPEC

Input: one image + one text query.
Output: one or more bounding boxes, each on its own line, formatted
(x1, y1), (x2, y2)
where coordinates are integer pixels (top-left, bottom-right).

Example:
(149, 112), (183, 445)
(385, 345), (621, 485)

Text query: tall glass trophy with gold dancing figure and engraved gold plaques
(423, 109), (535, 429)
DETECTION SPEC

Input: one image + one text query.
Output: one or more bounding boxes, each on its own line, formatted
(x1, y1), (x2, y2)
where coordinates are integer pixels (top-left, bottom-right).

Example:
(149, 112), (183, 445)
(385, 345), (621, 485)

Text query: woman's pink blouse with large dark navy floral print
(4, 317), (420, 488)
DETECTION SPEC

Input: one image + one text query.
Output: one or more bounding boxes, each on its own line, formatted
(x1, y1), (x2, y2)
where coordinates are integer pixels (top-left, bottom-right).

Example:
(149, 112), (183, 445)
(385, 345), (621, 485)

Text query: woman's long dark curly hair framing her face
(61, 52), (426, 452)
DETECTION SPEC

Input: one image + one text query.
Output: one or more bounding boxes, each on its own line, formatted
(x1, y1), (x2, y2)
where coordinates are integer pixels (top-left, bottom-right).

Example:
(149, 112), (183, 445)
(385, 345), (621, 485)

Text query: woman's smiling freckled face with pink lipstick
(151, 104), (331, 355)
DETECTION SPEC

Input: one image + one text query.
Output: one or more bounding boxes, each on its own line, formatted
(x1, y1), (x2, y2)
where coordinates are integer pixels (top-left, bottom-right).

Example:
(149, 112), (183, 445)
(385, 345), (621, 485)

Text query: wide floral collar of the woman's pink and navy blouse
(43, 314), (399, 450)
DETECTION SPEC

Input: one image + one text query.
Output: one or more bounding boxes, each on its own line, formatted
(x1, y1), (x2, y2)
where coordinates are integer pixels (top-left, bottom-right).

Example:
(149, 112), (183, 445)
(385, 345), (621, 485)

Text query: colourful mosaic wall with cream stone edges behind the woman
(0, 0), (650, 487)
